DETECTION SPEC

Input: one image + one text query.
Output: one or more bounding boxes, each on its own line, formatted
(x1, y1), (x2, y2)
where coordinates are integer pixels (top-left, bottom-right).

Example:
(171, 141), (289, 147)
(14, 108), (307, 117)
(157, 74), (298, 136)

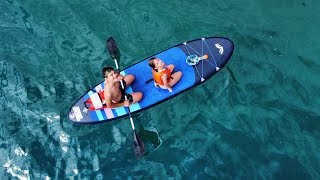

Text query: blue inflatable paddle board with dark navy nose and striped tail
(68, 37), (234, 124)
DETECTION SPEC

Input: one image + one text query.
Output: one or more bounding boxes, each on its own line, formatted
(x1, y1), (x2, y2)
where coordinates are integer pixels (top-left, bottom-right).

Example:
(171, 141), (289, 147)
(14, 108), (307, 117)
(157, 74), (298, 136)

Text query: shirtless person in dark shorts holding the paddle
(102, 66), (142, 108)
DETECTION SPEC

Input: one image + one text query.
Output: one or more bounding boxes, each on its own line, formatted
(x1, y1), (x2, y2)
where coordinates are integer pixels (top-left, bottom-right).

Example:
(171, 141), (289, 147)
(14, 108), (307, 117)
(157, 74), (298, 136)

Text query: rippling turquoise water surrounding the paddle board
(0, 0), (320, 179)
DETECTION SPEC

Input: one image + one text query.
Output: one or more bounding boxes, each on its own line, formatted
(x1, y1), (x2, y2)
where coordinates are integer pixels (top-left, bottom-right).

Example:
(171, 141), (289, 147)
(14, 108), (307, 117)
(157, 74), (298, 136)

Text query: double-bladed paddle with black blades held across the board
(107, 37), (144, 158)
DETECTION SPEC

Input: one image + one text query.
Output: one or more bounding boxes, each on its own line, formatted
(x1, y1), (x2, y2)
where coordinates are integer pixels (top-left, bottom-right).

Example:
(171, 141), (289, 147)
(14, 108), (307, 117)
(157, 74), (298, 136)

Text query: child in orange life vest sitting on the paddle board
(148, 57), (182, 92)
